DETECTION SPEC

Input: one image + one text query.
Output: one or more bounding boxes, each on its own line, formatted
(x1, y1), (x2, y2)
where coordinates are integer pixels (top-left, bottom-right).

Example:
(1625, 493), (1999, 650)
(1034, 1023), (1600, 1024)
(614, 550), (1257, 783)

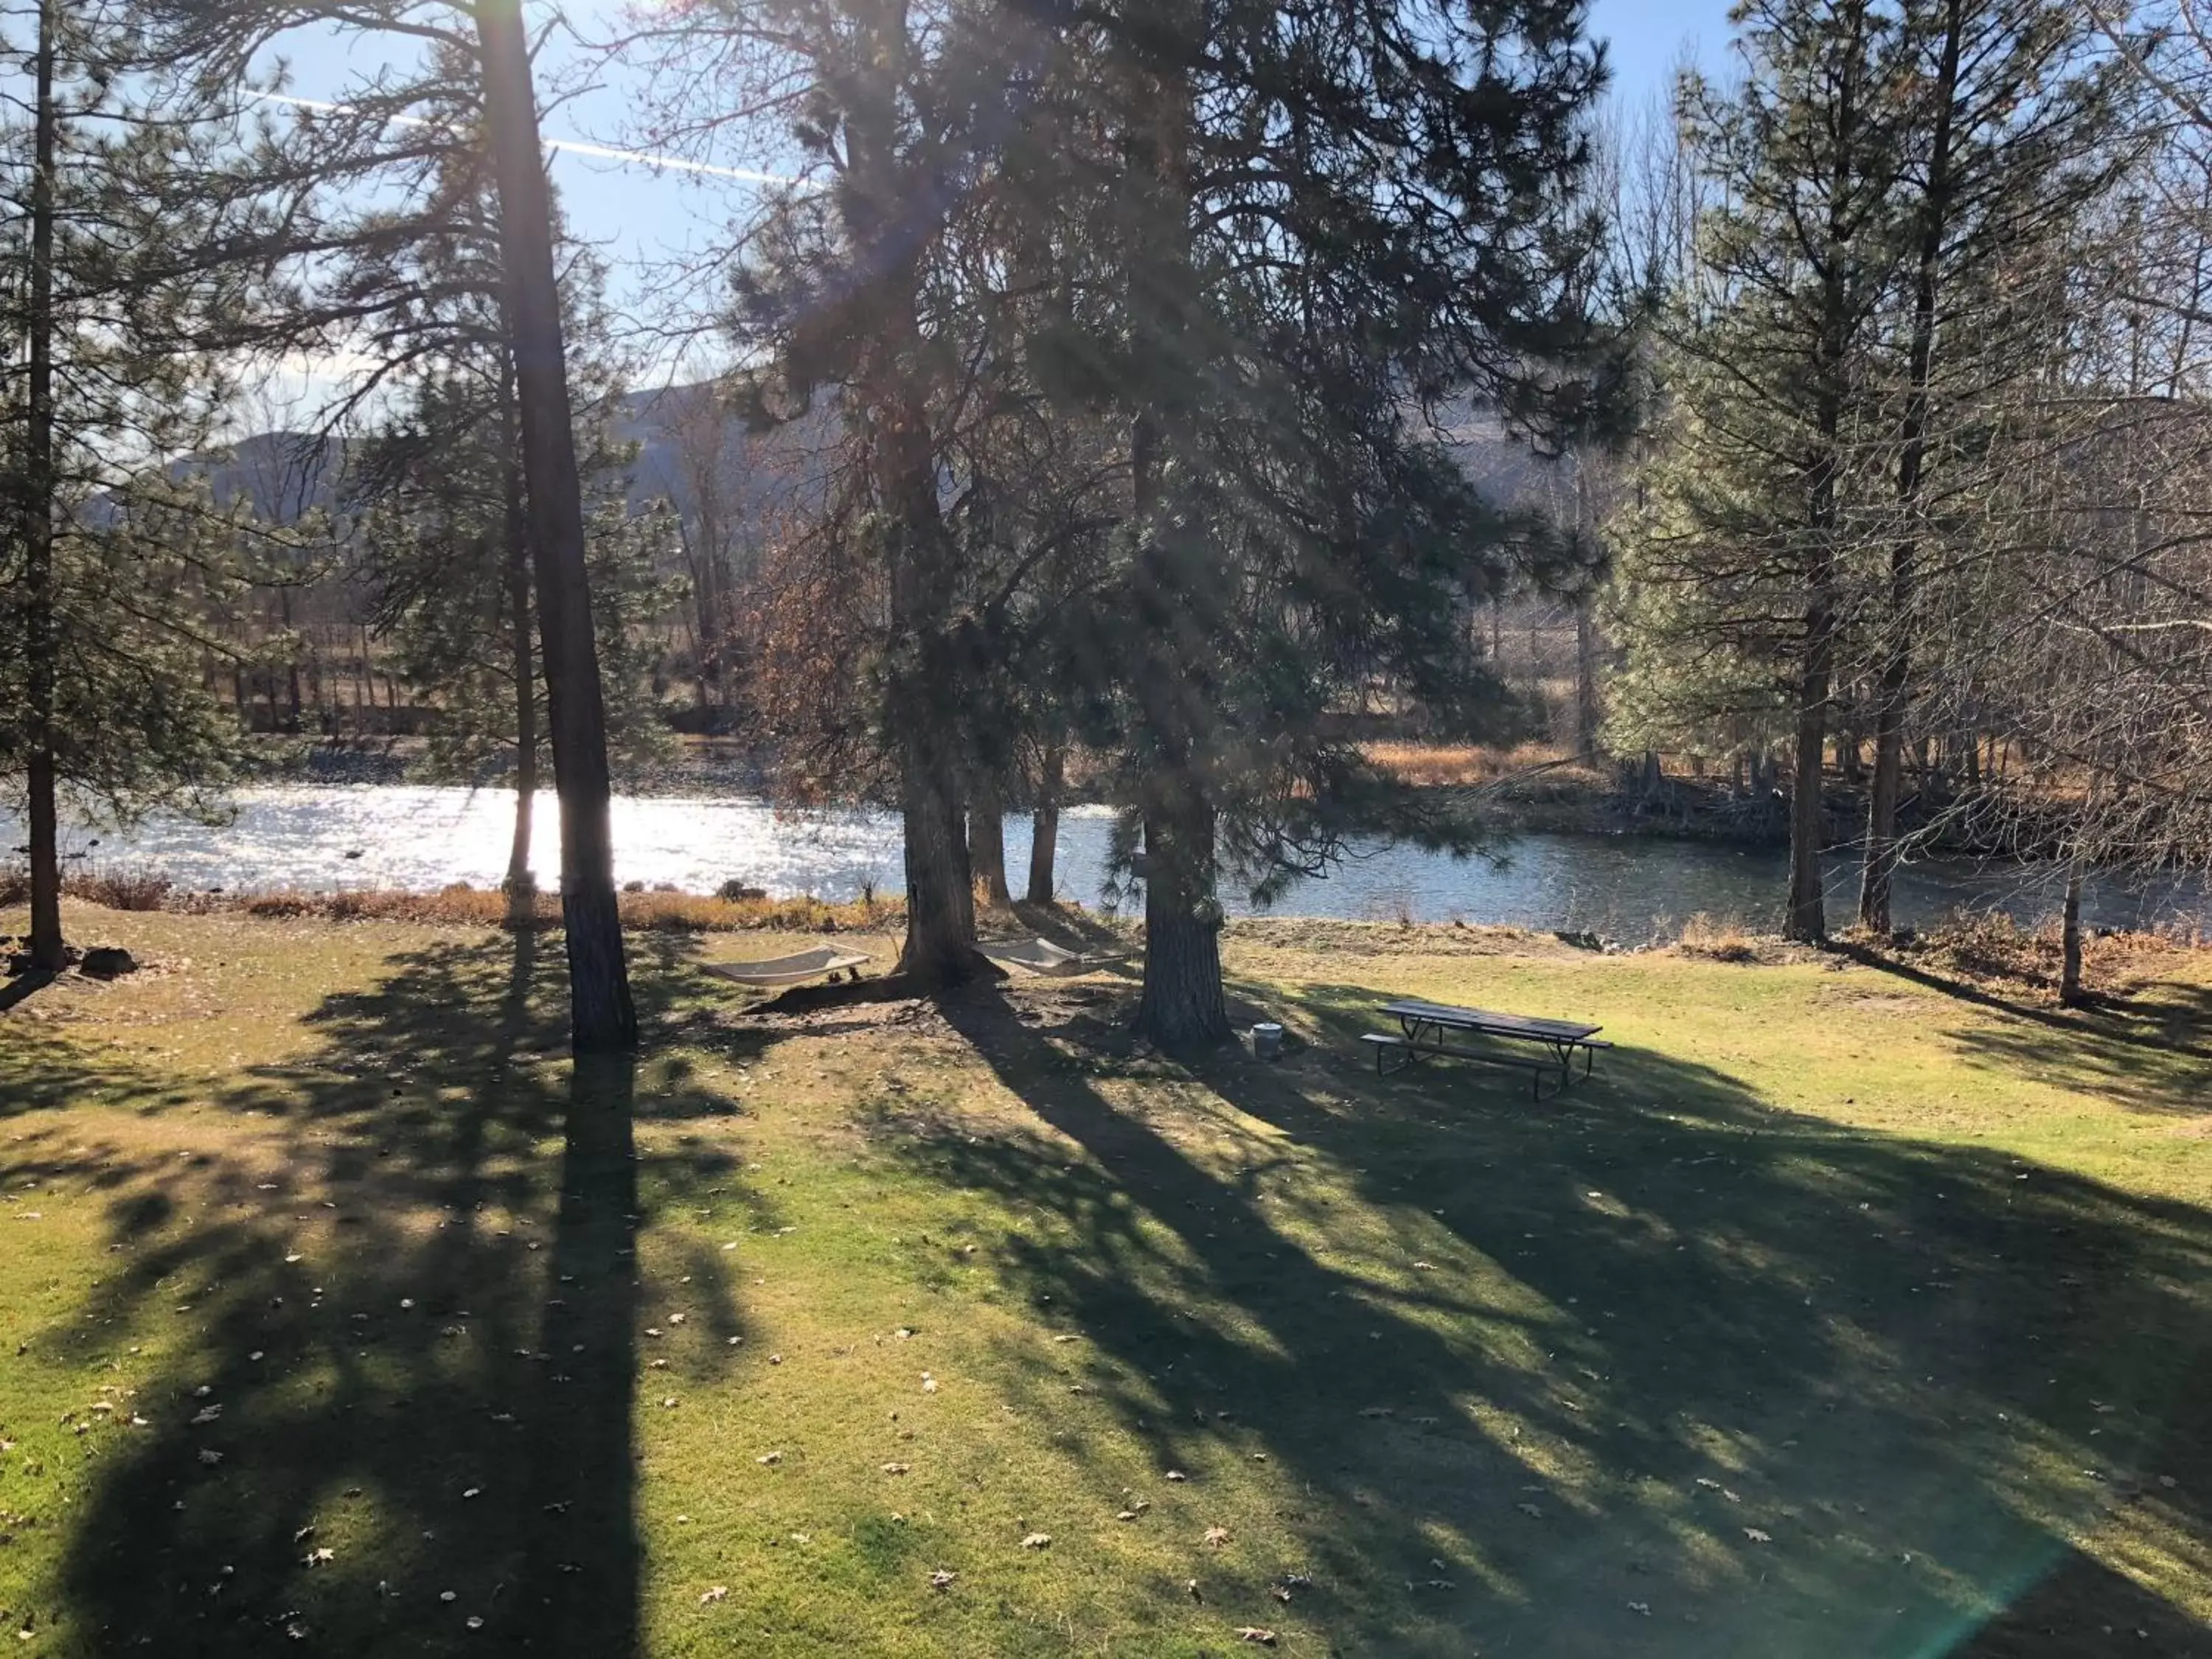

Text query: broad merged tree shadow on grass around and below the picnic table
(907, 987), (2212, 1659)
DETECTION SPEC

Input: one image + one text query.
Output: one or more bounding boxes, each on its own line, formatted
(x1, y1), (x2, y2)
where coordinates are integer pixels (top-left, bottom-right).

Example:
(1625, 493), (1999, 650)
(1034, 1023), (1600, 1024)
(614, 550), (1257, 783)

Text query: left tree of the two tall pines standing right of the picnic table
(1619, 0), (1909, 940)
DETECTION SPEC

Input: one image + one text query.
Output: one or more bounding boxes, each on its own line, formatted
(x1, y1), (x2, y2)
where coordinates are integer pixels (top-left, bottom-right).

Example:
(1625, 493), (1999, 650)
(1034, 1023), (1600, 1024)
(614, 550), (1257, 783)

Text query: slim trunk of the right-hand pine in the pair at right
(1858, 0), (1964, 933)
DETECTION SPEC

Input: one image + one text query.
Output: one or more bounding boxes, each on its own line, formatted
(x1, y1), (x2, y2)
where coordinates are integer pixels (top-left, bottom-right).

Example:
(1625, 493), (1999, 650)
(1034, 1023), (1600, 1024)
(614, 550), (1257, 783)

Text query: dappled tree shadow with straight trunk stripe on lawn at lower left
(35, 931), (737, 1655)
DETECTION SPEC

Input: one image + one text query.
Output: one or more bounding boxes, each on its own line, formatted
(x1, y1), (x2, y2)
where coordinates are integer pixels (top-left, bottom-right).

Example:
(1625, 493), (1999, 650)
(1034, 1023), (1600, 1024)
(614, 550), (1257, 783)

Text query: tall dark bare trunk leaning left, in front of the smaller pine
(476, 0), (637, 1053)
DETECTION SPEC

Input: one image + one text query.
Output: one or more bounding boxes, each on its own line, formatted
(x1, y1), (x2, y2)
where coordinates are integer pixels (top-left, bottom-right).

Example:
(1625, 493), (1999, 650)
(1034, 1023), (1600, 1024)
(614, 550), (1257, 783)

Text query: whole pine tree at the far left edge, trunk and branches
(0, 0), (272, 971)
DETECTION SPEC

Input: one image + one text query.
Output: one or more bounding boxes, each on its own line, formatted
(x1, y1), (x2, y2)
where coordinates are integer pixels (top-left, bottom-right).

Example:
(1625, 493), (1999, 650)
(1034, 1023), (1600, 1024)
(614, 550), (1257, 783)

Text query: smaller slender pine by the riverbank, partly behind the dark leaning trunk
(334, 117), (668, 914)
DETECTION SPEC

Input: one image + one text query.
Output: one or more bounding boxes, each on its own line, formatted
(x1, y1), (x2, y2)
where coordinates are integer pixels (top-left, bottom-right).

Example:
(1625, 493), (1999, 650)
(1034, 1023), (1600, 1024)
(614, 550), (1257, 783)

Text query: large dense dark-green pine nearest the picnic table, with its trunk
(1044, 0), (1604, 1044)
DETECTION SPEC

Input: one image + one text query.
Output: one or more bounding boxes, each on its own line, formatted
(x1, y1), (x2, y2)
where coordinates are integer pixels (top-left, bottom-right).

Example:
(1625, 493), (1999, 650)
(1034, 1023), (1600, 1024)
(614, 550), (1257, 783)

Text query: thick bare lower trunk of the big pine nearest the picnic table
(1137, 796), (1230, 1048)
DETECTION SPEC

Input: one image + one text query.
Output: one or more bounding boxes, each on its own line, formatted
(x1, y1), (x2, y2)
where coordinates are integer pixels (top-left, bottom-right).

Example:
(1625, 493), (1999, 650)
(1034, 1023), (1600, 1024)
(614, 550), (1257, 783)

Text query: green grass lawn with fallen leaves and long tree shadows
(0, 907), (2212, 1659)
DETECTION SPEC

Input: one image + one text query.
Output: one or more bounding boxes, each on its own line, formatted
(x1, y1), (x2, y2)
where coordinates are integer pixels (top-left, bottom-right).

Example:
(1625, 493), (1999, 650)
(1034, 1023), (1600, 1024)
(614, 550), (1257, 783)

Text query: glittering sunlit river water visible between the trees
(0, 785), (2212, 942)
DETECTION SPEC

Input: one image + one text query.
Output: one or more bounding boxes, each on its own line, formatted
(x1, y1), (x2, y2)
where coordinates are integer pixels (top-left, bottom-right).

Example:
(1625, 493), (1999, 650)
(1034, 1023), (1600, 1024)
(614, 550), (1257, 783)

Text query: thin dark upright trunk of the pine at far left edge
(22, 0), (69, 973)
